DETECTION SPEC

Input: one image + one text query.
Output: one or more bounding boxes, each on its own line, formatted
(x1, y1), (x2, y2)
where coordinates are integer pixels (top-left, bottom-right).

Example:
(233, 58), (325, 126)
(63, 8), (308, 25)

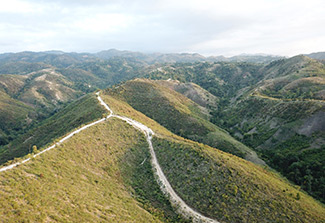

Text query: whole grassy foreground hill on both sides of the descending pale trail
(0, 91), (325, 222)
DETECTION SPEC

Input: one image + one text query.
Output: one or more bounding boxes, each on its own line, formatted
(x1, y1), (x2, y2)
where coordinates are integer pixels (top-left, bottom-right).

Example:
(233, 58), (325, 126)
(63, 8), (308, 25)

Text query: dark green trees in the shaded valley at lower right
(264, 135), (325, 202)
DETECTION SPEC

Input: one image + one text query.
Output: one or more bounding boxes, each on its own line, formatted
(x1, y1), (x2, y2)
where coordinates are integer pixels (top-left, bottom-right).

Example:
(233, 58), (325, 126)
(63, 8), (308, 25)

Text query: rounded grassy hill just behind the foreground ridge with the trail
(106, 79), (263, 163)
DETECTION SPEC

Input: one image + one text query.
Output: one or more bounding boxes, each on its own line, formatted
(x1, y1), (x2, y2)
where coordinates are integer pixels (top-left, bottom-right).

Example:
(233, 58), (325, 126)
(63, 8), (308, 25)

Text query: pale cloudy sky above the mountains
(0, 0), (325, 56)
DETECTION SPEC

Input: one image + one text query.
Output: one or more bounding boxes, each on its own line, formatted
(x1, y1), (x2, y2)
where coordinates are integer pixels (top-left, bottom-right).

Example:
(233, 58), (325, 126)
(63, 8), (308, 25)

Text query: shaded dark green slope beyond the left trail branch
(0, 94), (105, 163)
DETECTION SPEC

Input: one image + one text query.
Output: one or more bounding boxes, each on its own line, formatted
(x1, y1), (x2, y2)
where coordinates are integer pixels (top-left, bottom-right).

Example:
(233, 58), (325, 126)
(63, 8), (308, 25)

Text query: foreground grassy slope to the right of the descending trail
(102, 91), (325, 222)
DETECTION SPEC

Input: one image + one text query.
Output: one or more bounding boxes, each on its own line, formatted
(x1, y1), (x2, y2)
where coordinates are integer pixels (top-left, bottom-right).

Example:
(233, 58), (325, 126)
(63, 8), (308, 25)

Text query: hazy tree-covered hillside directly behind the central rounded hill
(145, 62), (263, 104)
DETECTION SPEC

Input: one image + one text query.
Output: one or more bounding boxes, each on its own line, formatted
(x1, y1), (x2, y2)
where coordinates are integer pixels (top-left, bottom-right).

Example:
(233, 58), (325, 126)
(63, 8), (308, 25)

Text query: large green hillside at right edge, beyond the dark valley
(214, 56), (325, 202)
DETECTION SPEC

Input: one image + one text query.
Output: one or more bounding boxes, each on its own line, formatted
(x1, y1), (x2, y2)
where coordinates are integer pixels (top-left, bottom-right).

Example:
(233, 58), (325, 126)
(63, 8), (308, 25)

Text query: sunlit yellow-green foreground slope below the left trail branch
(0, 120), (159, 222)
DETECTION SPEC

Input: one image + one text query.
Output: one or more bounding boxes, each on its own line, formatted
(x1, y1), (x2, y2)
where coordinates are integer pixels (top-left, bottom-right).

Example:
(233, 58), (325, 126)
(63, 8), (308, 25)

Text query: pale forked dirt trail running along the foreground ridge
(0, 92), (218, 223)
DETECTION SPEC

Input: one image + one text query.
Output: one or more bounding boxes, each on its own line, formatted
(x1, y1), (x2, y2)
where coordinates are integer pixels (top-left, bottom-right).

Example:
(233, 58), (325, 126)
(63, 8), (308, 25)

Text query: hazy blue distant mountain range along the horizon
(0, 49), (284, 67)
